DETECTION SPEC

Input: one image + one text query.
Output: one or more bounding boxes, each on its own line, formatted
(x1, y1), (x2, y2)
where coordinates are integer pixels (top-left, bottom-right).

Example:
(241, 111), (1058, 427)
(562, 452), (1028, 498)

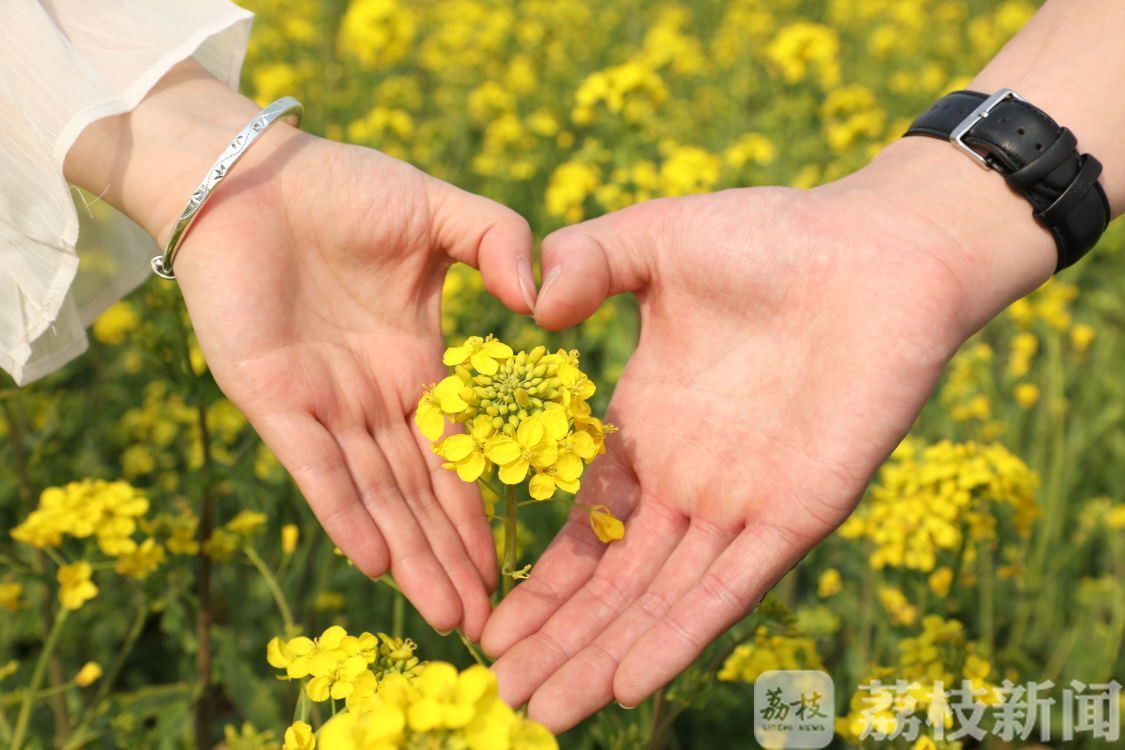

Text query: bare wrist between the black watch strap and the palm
(826, 138), (1058, 333)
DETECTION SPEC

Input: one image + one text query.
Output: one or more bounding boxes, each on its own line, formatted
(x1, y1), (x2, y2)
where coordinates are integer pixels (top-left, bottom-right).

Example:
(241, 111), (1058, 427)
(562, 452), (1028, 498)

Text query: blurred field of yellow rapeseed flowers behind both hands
(0, 0), (1125, 750)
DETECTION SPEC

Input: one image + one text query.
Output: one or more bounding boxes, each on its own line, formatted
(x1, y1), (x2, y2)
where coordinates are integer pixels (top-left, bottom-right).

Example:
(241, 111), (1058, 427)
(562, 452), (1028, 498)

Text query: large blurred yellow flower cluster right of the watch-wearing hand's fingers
(839, 439), (1038, 572)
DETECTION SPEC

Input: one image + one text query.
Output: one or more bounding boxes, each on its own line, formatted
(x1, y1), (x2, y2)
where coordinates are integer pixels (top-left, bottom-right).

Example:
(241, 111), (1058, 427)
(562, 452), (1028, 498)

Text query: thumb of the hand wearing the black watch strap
(536, 199), (678, 331)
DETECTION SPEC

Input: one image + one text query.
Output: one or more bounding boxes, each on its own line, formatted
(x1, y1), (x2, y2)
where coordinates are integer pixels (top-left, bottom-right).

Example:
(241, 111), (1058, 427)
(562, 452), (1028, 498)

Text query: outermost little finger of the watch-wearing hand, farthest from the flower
(613, 524), (808, 706)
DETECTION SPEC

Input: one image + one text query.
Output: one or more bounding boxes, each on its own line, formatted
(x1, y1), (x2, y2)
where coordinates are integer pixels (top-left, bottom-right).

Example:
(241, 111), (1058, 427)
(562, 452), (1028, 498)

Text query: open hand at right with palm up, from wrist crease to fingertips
(484, 184), (962, 729)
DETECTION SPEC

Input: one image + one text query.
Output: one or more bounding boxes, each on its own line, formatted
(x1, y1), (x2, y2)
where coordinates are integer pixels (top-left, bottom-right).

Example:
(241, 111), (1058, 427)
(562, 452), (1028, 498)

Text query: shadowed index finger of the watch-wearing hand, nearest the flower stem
(480, 451), (639, 659)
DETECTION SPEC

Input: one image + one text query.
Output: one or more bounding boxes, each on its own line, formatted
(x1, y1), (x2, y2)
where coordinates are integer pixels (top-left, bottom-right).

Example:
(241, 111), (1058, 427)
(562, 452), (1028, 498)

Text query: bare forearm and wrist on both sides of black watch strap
(827, 0), (1125, 327)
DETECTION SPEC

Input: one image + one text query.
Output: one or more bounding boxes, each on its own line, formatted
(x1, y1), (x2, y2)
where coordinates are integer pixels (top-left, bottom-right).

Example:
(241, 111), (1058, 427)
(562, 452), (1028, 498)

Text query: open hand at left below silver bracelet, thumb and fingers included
(177, 136), (530, 636)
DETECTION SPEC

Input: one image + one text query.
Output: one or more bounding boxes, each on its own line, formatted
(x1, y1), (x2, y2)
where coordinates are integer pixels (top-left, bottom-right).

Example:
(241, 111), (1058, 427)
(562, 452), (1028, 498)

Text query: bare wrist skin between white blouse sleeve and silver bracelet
(64, 60), (299, 244)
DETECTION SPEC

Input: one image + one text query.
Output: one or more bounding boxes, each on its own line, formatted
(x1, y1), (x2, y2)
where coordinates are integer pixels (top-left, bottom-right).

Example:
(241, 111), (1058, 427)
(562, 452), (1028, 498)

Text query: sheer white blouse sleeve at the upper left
(0, 0), (252, 385)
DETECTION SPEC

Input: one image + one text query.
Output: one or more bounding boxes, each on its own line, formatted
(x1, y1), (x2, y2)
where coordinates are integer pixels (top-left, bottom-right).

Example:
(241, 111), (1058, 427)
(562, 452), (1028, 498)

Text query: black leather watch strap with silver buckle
(906, 90), (1110, 271)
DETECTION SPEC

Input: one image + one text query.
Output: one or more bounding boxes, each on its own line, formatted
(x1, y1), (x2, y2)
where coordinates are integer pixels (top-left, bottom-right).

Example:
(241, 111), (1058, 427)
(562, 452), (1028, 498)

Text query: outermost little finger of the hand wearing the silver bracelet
(251, 414), (390, 578)
